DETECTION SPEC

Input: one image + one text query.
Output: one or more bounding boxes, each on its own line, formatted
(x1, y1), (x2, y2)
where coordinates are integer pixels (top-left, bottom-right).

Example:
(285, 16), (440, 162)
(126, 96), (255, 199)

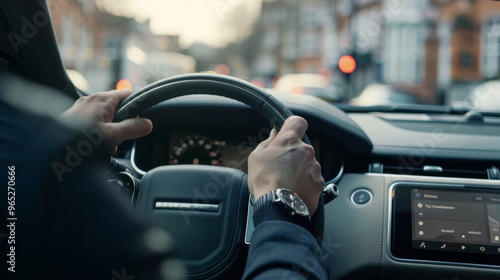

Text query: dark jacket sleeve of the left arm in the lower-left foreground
(0, 86), (183, 279)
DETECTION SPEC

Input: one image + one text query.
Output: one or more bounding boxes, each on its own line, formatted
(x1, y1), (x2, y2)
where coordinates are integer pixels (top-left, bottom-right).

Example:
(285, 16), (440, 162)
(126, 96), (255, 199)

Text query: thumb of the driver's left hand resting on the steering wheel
(101, 118), (153, 145)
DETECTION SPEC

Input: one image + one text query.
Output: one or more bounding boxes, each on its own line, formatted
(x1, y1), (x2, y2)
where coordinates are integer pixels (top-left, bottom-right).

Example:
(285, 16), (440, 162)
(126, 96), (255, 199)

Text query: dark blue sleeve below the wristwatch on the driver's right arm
(243, 203), (328, 280)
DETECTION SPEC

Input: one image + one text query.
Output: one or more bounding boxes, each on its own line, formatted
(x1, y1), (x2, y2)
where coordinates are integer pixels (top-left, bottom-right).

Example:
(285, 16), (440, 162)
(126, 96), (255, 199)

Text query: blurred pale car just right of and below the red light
(349, 84), (421, 106)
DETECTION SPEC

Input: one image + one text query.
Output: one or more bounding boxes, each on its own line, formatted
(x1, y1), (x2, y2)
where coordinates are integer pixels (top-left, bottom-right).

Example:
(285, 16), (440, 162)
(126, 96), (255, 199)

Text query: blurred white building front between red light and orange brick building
(381, 0), (435, 103)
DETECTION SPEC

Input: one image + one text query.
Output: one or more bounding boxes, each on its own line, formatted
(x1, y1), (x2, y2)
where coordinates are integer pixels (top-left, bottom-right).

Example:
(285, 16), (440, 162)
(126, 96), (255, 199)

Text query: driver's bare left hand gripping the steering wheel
(63, 89), (153, 153)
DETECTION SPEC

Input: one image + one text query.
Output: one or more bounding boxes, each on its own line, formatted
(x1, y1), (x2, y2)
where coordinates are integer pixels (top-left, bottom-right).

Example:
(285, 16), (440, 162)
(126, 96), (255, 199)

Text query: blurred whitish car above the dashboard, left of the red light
(274, 73), (342, 102)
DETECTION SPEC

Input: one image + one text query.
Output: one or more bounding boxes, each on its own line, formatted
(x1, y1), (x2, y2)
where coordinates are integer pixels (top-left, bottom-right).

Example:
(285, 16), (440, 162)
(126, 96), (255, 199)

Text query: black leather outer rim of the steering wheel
(113, 74), (324, 278)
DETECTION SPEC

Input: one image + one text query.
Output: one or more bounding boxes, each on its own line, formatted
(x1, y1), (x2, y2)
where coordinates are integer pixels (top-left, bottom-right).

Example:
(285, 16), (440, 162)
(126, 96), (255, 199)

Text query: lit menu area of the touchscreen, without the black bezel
(411, 188), (500, 254)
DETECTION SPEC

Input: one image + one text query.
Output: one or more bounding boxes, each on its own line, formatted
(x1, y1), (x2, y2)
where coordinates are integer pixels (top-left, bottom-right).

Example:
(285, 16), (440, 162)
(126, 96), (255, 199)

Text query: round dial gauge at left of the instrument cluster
(169, 135), (223, 166)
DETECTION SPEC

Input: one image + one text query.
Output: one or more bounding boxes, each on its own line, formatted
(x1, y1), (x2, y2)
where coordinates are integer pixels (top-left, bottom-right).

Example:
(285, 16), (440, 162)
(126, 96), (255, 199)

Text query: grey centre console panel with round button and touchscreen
(322, 173), (500, 280)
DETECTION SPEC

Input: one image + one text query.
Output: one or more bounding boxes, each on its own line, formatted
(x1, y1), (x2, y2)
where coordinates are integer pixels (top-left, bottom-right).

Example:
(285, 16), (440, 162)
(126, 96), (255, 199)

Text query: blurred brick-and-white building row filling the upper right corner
(334, 0), (500, 104)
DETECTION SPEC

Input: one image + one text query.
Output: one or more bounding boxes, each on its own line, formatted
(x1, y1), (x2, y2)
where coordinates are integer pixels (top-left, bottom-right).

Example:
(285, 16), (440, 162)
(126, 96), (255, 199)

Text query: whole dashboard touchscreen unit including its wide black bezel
(390, 182), (500, 266)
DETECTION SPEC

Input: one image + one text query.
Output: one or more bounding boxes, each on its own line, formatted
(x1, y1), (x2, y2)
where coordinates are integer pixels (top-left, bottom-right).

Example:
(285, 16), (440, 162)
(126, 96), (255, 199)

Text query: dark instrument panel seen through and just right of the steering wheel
(129, 96), (345, 180)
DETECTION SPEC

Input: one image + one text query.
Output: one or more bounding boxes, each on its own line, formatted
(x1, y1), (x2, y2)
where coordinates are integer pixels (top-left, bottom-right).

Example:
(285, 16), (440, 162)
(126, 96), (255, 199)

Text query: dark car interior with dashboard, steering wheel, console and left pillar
(0, 1), (500, 280)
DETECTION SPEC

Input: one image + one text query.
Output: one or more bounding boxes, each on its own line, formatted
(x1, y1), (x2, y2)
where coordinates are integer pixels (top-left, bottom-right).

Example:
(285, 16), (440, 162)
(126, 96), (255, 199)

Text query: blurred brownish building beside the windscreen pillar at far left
(48, 0), (131, 92)
